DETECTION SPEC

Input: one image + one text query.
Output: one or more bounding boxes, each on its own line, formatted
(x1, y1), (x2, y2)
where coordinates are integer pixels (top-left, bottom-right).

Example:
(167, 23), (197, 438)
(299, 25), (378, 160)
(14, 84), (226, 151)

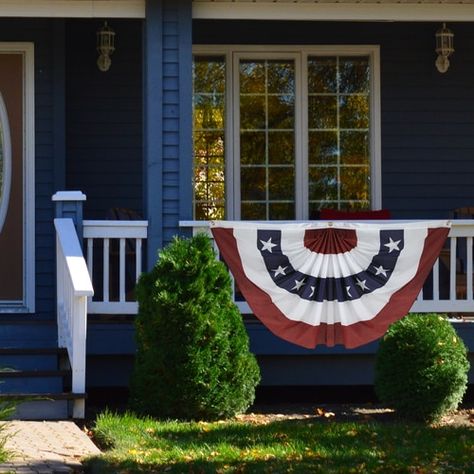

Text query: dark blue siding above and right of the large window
(193, 20), (474, 219)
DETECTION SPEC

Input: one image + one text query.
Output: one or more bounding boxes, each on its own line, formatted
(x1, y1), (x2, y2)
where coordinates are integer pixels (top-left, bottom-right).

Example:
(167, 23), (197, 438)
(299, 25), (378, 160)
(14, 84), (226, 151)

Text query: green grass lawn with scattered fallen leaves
(82, 413), (474, 474)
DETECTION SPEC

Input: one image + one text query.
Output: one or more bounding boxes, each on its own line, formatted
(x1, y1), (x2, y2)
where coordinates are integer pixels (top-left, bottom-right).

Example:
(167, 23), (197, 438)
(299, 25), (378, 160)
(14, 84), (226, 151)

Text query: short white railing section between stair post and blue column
(83, 220), (148, 314)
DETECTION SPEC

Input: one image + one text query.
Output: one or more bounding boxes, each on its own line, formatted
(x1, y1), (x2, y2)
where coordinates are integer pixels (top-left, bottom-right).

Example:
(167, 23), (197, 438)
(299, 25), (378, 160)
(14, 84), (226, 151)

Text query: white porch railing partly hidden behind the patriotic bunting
(180, 220), (474, 316)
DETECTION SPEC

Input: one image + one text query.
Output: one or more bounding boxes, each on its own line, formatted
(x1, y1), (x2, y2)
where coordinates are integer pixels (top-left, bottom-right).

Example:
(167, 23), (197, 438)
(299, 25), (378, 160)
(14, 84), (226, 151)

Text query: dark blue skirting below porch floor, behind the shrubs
(87, 321), (474, 387)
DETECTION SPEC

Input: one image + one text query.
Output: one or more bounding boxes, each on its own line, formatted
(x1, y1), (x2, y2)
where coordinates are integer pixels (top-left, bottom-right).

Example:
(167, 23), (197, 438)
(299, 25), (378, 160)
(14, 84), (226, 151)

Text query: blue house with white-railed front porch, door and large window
(0, 0), (474, 418)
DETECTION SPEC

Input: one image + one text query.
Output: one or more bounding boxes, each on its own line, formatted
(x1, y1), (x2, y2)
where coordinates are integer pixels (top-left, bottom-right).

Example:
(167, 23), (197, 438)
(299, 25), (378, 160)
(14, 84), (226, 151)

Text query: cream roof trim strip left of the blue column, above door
(0, 0), (145, 18)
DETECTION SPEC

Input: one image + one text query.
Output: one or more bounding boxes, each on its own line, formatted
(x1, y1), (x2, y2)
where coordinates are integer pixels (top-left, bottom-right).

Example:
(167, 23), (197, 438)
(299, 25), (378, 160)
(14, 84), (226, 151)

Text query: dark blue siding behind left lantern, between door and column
(65, 20), (143, 219)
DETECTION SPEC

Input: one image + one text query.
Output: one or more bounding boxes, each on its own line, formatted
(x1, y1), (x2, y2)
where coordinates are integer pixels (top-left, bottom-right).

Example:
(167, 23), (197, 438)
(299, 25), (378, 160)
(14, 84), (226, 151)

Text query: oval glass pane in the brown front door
(0, 94), (12, 234)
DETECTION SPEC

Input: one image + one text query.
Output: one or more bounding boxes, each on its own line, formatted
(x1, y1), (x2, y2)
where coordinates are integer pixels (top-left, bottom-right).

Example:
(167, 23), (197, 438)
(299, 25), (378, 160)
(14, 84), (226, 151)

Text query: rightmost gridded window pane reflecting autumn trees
(308, 56), (370, 215)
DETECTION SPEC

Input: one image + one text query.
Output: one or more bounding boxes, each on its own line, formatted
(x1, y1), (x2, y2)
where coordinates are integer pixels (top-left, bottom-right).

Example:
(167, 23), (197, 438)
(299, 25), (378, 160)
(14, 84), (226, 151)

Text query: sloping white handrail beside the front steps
(54, 219), (94, 418)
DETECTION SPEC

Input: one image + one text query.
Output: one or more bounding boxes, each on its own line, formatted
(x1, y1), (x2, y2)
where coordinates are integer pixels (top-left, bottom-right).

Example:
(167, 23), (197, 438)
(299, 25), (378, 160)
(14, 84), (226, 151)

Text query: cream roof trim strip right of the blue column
(193, 0), (474, 22)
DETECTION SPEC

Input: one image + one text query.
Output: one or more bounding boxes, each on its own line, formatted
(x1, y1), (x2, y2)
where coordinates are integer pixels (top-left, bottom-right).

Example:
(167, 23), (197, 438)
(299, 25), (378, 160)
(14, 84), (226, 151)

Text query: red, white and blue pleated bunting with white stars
(211, 221), (450, 348)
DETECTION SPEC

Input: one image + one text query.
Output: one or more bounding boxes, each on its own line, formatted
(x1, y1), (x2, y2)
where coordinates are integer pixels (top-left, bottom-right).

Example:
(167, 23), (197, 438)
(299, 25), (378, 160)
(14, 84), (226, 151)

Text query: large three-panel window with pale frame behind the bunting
(193, 47), (381, 220)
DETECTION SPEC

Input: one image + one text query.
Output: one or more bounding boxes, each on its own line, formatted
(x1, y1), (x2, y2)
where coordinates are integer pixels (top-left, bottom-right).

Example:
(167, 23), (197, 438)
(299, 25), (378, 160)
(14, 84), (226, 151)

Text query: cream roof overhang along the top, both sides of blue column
(0, 0), (474, 22)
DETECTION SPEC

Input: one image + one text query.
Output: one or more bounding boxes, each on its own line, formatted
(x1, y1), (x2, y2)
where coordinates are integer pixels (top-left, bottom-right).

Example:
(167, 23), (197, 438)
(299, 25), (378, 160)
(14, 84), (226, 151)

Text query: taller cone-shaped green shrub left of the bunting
(131, 234), (260, 419)
